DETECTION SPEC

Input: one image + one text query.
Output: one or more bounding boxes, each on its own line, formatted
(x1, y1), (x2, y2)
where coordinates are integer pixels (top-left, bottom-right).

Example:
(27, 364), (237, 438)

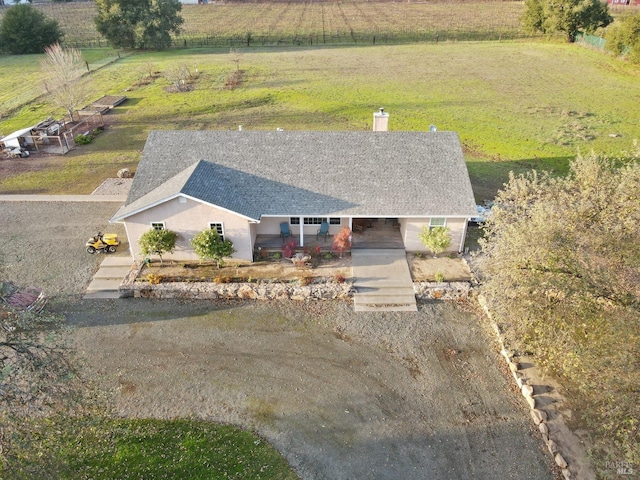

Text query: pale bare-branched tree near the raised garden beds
(40, 43), (88, 121)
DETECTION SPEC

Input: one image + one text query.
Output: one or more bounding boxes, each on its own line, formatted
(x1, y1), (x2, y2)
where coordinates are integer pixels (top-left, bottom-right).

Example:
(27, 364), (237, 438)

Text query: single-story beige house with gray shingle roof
(111, 115), (476, 260)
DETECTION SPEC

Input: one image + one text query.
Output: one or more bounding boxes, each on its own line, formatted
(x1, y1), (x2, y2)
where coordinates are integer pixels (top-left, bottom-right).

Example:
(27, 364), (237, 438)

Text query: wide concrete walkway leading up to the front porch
(351, 249), (418, 312)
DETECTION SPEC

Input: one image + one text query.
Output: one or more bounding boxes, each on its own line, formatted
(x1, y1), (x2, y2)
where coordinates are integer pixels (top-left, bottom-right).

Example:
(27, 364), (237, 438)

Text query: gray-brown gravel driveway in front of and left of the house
(0, 203), (554, 480)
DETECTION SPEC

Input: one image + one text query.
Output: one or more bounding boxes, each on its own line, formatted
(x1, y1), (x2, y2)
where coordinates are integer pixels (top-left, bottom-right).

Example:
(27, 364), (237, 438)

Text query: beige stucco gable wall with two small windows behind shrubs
(125, 198), (253, 260)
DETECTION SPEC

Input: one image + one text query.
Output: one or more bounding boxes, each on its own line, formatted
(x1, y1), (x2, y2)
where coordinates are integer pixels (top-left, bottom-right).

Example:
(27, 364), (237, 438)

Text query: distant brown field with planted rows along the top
(21, 1), (525, 48)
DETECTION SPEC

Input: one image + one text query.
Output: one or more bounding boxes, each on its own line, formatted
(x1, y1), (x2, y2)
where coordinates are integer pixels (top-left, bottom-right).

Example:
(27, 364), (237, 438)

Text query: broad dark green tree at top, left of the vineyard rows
(95, 0), (183, 49)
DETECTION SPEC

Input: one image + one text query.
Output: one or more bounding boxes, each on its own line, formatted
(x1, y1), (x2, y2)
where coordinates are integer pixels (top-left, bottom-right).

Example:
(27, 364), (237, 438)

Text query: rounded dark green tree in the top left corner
(0, 5), (62, 55)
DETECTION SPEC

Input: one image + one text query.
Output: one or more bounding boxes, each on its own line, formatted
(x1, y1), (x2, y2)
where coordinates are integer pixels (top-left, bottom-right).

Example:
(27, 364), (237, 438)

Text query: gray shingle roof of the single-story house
(114, 131), (476, 220)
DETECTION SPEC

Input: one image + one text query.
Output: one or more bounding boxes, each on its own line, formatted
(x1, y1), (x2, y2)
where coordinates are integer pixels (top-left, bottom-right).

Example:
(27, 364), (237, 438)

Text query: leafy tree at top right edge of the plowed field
(521, 0), (613, 42)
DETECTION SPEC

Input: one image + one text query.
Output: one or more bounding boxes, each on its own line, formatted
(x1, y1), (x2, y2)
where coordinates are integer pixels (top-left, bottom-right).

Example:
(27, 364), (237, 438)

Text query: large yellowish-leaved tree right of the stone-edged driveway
(482, 154), (640, 463)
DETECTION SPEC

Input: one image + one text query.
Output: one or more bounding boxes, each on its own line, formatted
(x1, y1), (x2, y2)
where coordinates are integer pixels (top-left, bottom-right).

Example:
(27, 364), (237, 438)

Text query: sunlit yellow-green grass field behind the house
(0, 42), (640, 200)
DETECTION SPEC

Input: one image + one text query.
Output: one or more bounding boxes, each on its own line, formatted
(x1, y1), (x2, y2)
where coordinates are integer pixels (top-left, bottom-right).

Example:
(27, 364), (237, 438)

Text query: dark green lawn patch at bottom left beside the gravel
(5, 417), (298, 480)
